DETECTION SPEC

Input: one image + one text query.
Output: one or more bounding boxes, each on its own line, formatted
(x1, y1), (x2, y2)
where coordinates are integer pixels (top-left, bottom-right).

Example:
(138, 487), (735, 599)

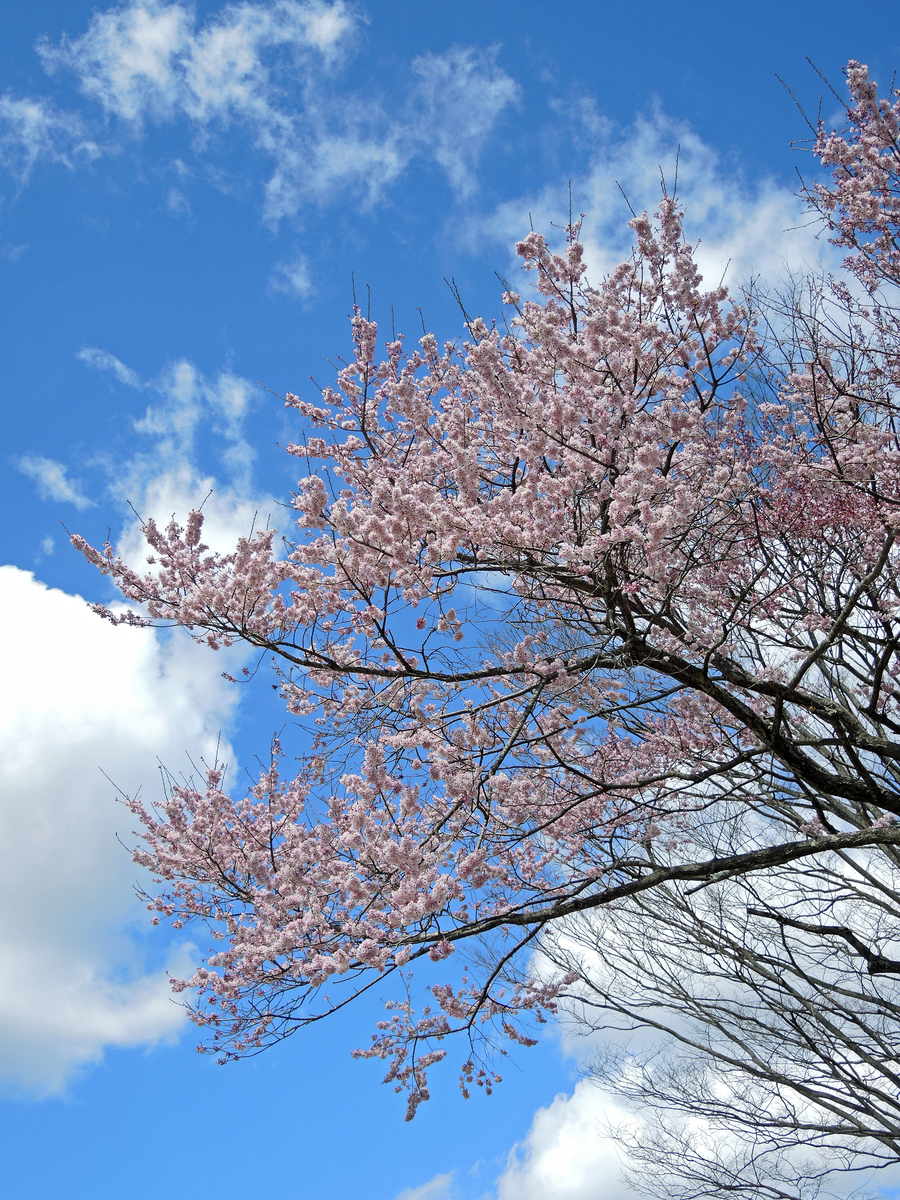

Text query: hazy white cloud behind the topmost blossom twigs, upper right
(475, 104), (836, 295)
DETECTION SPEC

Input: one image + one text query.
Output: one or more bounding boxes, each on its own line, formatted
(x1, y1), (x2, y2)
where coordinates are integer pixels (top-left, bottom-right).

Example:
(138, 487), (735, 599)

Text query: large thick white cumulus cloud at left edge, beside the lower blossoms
(0, 566), (243, 1094)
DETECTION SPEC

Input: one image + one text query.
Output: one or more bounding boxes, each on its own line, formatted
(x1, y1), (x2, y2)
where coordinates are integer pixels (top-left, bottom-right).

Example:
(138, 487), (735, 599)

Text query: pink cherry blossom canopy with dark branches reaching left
(74, 64), (900, 1114)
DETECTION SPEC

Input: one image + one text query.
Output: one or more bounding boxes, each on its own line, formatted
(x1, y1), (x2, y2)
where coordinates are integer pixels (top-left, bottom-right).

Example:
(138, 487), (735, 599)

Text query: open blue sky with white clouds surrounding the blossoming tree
(0, 0), (900, 1200)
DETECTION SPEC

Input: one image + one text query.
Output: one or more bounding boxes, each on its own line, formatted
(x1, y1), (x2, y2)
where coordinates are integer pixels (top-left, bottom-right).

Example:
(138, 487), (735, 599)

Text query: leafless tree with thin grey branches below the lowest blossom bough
(542, 811), (900, 1200)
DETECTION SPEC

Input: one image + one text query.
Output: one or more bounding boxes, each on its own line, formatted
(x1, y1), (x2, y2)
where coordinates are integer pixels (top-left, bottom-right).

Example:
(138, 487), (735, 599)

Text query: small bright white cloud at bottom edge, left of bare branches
(497, 1080), (635, 1200)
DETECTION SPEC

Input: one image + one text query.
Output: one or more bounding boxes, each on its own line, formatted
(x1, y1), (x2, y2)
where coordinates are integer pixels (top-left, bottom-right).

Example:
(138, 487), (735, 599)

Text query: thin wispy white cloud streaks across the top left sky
(0, 0), (518, 224)
